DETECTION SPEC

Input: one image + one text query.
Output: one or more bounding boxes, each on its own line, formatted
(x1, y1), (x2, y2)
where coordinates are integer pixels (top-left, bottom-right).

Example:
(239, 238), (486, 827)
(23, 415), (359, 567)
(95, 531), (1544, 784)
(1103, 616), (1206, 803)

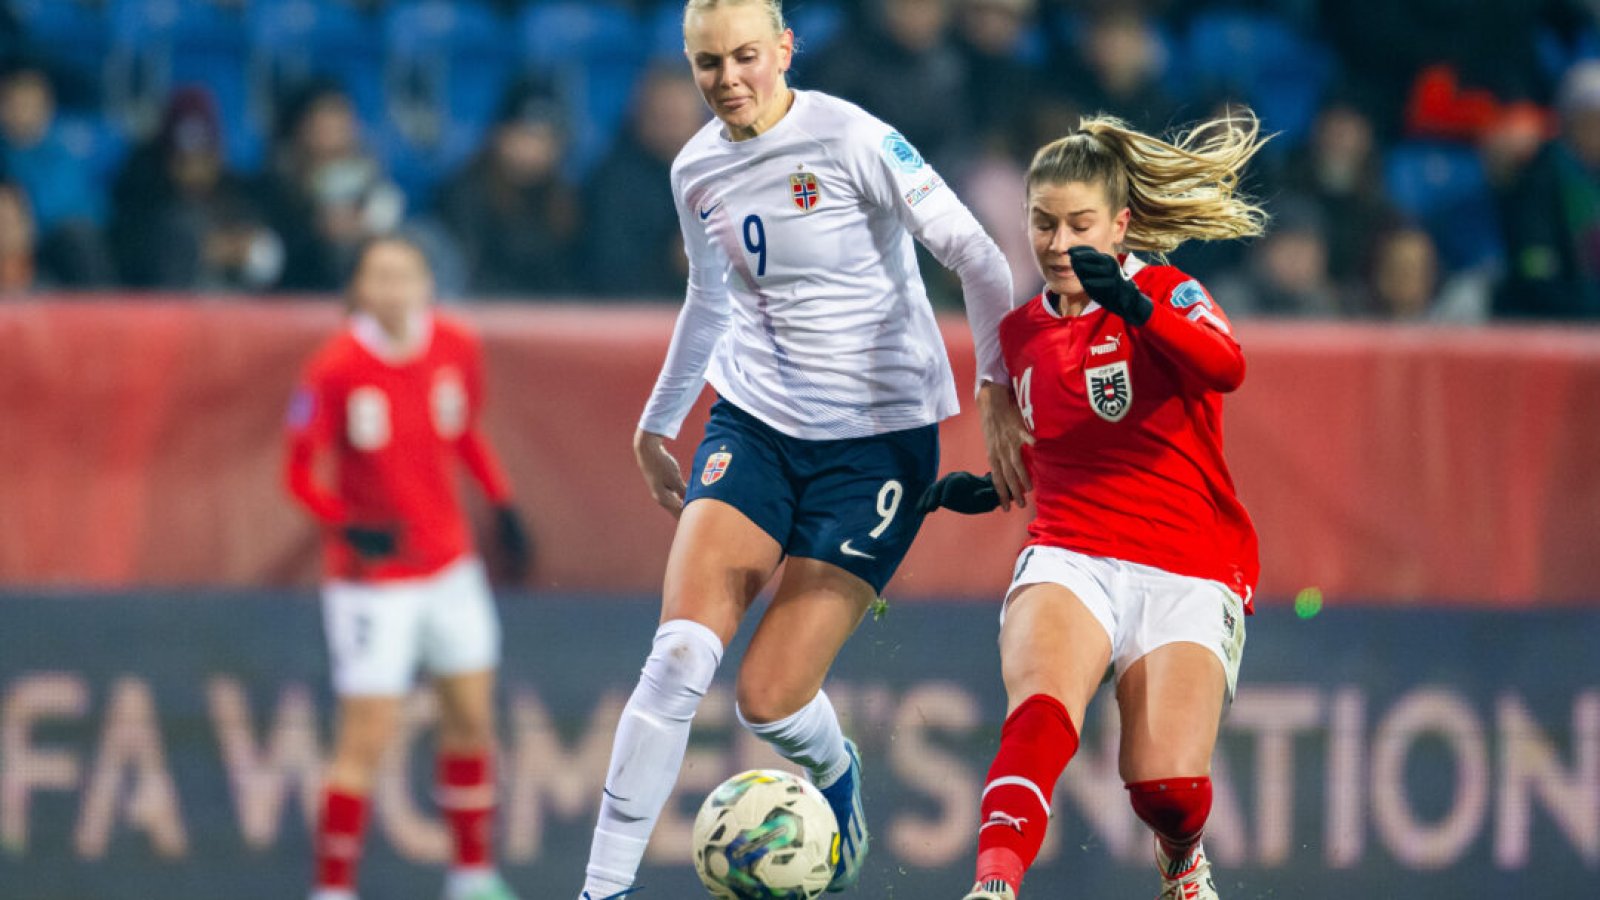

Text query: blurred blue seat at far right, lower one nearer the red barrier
(1384, 141), (1504, 271)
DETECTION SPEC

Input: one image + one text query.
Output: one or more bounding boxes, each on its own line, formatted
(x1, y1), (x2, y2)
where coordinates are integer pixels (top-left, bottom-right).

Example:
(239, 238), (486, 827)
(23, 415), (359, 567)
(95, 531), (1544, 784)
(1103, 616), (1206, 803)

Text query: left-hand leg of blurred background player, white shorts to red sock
(312, 581), (421, 900)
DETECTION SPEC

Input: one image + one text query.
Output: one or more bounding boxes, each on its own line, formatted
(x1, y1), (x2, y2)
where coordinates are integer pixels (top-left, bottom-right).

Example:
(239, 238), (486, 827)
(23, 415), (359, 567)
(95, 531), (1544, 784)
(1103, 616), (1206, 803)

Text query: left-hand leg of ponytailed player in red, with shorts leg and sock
(968, 548), (1112, 900)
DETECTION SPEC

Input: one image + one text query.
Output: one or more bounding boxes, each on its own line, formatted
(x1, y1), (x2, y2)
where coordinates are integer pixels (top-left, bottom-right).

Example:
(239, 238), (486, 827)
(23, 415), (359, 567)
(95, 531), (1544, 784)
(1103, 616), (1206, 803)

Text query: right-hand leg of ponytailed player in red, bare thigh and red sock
(1117, 642), (1227, 900)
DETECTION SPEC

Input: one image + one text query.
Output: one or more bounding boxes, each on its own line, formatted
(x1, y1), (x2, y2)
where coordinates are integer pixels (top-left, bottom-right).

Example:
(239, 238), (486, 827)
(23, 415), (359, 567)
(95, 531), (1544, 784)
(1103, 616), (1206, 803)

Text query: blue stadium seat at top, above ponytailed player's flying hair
(1182, 11), (1334, 149)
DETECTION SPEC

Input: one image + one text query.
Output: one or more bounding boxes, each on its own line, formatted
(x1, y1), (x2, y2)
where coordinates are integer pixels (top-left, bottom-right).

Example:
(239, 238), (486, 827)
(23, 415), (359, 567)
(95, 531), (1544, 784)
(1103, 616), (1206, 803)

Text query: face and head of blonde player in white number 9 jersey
(683, 3), (795, 141)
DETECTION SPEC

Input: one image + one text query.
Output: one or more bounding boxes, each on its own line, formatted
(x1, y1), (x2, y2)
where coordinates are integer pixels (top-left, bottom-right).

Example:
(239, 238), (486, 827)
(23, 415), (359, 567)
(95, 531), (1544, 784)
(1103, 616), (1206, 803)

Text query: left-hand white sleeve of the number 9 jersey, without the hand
(638, 171), (731, 437)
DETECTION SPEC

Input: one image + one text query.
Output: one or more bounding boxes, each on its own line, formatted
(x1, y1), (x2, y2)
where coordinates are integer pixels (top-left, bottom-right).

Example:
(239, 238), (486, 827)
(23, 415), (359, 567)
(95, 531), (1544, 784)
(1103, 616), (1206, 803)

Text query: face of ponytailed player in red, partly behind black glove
(1027, 181), (1133, 298)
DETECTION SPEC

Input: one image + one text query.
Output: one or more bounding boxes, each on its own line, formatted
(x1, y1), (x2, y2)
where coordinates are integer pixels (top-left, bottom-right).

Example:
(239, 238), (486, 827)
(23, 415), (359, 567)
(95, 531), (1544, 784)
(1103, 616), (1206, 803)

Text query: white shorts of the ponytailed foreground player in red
(1000, 546), (1245, 700)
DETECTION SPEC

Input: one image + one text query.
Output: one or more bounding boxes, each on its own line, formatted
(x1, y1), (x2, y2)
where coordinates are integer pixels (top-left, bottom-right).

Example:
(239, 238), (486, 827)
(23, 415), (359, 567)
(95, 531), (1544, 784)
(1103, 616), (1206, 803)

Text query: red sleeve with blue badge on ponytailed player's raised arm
(1144, 271), (1245, 394)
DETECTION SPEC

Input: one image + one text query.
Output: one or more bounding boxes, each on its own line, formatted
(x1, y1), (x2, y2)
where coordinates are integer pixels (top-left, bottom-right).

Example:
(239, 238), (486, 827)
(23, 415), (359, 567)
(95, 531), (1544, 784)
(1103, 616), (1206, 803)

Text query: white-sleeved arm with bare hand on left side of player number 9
(634, 160), (733, 516)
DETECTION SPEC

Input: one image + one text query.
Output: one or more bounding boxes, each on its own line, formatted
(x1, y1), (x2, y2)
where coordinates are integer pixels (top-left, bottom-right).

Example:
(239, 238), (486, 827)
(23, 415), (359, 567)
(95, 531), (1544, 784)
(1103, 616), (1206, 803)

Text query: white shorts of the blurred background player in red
(322, 556), (499, 697)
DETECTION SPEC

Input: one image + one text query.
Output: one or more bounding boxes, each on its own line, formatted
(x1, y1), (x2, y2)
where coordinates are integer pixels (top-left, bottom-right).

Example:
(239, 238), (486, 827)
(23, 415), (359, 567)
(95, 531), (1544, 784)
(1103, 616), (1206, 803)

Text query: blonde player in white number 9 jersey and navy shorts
(582, 0), (1027, 900)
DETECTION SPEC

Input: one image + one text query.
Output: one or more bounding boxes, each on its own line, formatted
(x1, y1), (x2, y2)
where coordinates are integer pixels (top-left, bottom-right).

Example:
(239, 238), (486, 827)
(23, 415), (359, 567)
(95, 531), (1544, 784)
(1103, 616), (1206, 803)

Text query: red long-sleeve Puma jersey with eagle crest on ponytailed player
(1000, 256), (1259, 610)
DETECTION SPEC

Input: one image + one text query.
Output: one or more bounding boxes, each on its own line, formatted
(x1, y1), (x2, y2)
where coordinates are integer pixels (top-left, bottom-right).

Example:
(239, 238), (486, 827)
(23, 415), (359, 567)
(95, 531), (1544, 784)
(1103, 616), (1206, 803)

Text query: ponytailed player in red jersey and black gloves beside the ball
(923, 115), (1266, 900)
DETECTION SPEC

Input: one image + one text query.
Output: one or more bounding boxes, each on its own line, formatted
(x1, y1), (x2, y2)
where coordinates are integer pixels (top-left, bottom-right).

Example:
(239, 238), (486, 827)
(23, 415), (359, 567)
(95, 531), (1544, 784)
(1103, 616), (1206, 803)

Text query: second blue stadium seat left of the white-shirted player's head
(378, 0), (512, 199)
